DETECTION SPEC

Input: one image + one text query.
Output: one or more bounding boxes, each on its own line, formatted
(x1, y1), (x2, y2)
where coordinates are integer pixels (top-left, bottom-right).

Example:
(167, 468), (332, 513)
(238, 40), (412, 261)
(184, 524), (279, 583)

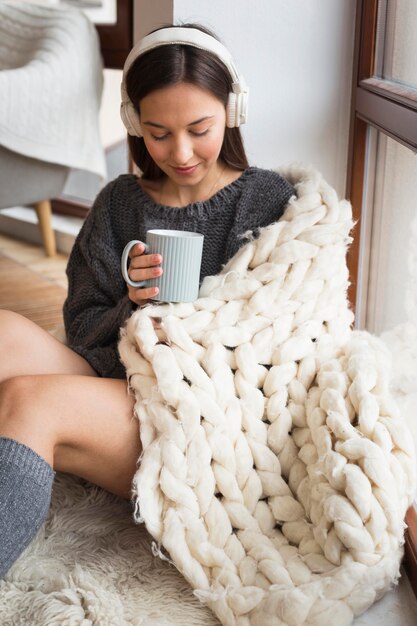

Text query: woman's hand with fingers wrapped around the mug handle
(127, 243), (163, 306)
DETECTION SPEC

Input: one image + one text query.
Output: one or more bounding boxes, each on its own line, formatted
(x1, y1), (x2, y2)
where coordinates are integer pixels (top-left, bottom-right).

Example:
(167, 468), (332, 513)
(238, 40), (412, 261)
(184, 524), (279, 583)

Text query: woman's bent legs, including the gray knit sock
(0, 311), (141, 578)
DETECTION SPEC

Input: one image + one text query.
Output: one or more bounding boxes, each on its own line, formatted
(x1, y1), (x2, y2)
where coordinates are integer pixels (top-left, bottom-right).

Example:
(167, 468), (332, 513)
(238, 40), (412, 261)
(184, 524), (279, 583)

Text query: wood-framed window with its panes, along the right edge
(347, 0), (417, 595)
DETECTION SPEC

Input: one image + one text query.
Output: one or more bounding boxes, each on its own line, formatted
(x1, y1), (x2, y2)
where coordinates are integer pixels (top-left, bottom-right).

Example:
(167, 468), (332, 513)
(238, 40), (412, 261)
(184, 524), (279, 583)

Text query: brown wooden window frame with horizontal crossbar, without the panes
(346, 0), (417, 597)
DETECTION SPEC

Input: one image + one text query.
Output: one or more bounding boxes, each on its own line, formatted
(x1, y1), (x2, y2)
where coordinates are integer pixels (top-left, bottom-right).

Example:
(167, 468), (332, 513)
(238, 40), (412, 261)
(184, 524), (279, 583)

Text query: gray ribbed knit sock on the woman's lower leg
(0, 437), (54, 578)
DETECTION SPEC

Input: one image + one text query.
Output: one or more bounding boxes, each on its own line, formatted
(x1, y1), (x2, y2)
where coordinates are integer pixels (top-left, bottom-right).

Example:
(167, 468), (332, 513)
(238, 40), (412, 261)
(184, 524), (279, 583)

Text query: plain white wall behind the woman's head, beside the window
(135, 0), (355, 195)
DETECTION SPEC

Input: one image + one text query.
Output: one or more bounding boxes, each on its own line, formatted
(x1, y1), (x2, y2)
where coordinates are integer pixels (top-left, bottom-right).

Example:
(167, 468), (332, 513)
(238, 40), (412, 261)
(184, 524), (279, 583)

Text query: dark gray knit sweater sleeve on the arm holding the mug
(64, 178), (134, 378)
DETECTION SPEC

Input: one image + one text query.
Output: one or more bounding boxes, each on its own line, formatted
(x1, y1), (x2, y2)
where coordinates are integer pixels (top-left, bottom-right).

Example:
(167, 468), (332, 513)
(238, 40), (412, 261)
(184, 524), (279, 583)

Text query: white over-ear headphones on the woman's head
(120, 26), (248, 137)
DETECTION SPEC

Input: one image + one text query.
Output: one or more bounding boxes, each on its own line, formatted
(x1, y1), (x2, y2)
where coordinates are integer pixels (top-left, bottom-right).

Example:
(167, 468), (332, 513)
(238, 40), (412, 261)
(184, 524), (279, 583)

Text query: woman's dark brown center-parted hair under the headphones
(126, 24), (249, 180)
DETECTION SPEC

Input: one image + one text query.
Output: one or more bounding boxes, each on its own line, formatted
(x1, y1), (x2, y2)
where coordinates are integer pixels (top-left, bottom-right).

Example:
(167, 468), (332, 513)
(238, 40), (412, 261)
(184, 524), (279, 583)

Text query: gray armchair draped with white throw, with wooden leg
(0, 2), (106, 254)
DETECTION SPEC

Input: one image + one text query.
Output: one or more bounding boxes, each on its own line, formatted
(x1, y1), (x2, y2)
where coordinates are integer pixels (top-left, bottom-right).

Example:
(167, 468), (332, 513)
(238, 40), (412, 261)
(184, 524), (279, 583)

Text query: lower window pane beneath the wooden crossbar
(356, 128), (417, 332)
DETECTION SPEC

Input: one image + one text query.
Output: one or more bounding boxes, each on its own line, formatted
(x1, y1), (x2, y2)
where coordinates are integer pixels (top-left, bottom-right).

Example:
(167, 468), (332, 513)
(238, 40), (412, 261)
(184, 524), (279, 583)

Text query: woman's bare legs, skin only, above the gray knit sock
(0, 311), (141, 497)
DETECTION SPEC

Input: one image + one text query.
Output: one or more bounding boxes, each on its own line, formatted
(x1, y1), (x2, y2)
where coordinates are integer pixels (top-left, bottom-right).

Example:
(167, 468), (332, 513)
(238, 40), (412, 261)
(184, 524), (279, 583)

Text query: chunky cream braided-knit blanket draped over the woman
(120, 166), (415, 626)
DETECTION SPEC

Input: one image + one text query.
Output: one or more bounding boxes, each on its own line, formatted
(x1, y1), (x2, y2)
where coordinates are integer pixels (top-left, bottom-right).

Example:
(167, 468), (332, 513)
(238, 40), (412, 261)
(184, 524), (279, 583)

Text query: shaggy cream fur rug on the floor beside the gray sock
(0, 474), (219, 626)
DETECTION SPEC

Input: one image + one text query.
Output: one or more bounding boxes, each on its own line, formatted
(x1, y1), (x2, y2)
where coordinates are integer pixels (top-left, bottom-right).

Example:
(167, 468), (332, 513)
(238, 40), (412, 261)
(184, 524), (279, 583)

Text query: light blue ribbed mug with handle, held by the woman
(121, 229), (204, 302)
